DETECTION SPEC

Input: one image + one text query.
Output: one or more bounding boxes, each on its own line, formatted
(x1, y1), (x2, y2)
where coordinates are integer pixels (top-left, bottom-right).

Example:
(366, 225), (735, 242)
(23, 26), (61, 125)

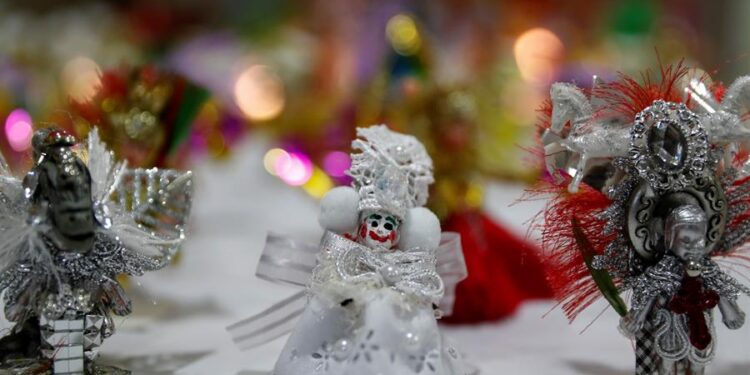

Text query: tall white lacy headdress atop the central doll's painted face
(348, 125), (434, 219)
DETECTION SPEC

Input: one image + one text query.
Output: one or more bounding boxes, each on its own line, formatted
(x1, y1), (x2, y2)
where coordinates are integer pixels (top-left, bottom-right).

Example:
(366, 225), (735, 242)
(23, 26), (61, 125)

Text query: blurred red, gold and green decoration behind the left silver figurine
(66, 65), (209, 168)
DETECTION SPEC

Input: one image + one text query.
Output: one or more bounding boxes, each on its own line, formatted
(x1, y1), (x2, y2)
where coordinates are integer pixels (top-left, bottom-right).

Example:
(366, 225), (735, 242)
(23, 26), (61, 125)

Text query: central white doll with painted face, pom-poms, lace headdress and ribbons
(229, 125), (476, 375)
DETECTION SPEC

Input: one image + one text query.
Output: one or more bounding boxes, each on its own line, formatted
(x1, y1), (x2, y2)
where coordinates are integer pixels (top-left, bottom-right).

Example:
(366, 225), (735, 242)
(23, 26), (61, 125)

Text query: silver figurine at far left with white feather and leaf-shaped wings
(0, 128), (192, 374)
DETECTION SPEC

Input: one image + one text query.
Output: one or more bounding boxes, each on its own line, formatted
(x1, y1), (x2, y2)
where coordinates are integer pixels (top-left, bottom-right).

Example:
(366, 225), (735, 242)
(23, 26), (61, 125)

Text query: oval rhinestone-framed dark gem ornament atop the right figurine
(628, 100), (710, 192)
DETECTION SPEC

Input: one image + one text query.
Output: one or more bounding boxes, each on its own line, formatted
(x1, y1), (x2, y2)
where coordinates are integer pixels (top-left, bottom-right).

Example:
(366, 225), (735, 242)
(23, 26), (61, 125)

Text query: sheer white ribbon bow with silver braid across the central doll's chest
(227, 232), (467, 350)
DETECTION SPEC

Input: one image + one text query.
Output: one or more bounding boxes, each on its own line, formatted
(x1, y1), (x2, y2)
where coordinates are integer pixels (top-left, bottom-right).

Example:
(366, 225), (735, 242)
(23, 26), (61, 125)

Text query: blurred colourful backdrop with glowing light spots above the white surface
(0, 0), (750, 179)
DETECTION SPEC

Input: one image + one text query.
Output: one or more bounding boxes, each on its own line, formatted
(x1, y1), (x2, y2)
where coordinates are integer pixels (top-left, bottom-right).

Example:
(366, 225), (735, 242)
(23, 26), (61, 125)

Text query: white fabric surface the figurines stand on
(5, 139), (750, 375)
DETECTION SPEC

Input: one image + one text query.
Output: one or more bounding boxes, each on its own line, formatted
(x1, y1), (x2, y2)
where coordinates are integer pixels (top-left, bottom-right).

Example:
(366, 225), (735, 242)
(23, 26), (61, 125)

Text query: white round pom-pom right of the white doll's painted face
(399, 207), (441, 250)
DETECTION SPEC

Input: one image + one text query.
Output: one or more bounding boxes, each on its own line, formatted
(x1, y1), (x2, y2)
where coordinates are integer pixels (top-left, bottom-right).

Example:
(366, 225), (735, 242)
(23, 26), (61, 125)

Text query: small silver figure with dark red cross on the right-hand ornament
(621, 204), (747, 375)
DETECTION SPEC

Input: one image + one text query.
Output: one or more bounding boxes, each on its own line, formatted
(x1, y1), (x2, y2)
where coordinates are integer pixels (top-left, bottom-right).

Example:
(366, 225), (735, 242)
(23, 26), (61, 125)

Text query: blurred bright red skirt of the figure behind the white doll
(442, 211), (552, 323)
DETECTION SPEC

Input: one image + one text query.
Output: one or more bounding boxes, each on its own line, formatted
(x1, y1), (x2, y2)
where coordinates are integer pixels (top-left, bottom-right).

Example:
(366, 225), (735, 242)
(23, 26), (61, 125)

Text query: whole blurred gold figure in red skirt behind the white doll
(362, 22), (552, 324)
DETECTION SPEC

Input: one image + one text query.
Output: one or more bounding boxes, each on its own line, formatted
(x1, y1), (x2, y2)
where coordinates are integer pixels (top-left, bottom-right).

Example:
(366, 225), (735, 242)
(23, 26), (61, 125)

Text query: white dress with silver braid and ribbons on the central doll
(229, 232), (477, 375)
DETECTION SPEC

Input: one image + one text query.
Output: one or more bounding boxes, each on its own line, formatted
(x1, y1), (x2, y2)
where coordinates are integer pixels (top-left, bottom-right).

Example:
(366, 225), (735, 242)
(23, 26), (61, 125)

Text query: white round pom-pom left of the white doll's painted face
(318, 186), (359, 233)
